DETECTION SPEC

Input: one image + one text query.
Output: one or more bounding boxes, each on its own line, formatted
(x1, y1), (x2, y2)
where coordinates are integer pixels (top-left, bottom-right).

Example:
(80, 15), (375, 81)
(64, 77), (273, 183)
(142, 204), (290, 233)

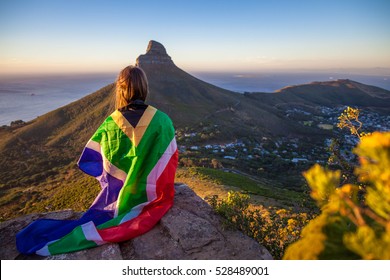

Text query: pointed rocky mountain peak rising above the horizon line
(136, 40), (174, 67)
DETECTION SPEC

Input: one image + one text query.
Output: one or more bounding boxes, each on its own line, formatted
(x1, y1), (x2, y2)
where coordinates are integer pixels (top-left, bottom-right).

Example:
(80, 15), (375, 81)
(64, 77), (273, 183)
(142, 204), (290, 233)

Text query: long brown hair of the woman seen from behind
(115, 66), (148, 109)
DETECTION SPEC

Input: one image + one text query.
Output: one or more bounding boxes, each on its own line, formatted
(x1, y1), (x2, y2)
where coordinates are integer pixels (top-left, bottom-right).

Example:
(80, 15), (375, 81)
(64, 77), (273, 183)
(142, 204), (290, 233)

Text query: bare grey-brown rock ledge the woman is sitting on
(0, 185), (272, 260)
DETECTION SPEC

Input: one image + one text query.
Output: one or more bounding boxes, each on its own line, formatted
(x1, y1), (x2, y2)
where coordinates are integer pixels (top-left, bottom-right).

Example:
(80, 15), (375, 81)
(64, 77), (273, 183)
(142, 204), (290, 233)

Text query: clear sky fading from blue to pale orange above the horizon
(0, 0), (390, 74)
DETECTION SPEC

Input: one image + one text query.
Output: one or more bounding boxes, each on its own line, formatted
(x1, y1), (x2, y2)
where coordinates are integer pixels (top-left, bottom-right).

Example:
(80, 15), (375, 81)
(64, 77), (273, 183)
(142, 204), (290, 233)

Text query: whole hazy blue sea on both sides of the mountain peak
(0, 72), (390, 126)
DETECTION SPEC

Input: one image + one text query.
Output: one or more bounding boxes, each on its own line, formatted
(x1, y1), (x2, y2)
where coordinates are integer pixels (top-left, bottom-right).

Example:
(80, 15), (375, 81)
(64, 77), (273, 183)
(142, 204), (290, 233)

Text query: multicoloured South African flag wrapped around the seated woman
(16, 103), (178, 256)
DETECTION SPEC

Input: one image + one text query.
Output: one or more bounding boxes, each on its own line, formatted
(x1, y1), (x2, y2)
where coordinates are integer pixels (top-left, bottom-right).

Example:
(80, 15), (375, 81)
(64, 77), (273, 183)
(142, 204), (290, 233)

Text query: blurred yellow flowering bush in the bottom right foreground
(284, 132), (390, 259)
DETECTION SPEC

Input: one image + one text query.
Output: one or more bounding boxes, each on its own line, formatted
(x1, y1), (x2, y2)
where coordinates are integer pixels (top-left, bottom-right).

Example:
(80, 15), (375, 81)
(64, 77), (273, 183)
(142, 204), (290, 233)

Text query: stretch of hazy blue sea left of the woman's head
(0, 74), (116, 126)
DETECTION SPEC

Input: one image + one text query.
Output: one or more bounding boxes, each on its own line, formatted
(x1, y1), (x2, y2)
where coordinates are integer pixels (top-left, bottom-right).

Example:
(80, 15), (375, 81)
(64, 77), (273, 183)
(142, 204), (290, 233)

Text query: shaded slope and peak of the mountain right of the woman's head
(137, 41), (314, 139)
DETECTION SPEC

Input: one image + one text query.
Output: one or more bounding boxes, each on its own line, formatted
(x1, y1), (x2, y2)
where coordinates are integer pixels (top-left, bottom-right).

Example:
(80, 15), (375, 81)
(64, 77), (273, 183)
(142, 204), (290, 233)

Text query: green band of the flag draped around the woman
(34, 107), (175, 254)
